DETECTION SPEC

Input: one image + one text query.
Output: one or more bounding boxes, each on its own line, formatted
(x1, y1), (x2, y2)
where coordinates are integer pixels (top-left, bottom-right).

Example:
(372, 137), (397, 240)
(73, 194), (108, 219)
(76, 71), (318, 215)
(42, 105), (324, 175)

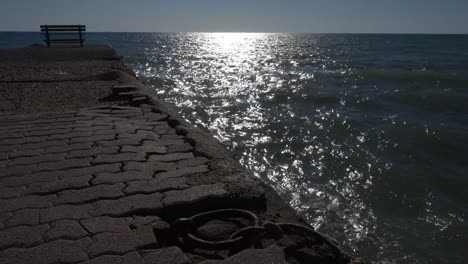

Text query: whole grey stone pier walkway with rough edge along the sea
(0, 47), (358, 264)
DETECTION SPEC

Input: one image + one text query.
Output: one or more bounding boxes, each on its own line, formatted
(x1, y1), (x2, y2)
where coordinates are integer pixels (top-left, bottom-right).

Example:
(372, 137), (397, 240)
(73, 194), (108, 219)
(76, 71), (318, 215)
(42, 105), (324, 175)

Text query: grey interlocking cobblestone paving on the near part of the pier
(0, 102), (252, 263)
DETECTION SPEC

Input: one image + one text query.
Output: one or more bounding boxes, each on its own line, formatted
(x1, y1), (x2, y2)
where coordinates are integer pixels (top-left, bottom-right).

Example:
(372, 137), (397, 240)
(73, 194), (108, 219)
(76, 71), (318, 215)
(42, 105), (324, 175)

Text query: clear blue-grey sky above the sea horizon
(0, 0), (468, 34)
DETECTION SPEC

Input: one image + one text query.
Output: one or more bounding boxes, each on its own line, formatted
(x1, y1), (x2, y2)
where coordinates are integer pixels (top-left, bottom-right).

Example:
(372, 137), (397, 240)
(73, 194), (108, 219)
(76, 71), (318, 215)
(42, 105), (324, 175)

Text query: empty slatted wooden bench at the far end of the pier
(41, 25), (86, 48)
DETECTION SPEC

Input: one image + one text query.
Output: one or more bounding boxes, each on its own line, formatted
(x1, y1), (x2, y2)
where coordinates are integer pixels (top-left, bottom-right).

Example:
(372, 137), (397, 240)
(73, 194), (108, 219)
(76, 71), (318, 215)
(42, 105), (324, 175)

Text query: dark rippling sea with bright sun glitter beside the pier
(0, 32), (468, 264)
